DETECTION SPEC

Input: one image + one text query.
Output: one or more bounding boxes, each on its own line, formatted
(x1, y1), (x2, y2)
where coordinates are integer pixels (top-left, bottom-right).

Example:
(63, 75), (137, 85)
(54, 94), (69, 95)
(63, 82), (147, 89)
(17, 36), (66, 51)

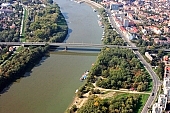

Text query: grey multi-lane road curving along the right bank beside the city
(106, 9), (161, 113)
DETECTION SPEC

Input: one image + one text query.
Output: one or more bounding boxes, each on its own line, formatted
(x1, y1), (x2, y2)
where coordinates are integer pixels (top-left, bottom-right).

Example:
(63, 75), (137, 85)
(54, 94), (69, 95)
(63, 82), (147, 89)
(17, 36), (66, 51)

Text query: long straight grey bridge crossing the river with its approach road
(0, 42), (170, 52)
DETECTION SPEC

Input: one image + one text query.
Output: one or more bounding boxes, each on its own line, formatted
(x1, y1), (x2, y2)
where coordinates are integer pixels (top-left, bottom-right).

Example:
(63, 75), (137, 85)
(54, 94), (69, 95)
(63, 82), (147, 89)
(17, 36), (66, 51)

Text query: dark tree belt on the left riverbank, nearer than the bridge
(0, 46), (48, 91)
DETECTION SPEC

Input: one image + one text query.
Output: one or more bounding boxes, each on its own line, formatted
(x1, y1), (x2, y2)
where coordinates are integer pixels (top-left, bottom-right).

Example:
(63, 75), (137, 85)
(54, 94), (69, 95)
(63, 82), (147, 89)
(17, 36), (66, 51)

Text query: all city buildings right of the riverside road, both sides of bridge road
(101, 0), (170, 113)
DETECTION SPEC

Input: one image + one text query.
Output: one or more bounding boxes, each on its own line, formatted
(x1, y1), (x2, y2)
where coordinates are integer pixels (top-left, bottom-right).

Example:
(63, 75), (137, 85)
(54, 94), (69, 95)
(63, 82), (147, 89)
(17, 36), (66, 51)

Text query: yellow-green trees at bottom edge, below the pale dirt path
(77, 93), (146, 113)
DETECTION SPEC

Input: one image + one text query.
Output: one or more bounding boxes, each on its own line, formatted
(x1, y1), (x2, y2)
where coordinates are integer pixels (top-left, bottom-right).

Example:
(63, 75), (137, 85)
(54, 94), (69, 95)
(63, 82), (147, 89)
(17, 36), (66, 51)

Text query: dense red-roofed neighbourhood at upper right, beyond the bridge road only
(101, 0), (170, 46)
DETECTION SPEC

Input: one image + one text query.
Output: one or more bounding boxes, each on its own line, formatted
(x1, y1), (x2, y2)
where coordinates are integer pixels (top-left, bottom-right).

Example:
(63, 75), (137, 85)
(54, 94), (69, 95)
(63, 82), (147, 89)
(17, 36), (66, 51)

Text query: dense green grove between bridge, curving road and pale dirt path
(88, 48), (150, 91)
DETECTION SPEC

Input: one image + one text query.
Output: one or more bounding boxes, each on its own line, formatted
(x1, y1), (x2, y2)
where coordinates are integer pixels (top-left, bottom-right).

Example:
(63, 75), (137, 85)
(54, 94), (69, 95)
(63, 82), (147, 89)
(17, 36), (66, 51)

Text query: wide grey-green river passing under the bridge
(0, 0), (103, 113)
